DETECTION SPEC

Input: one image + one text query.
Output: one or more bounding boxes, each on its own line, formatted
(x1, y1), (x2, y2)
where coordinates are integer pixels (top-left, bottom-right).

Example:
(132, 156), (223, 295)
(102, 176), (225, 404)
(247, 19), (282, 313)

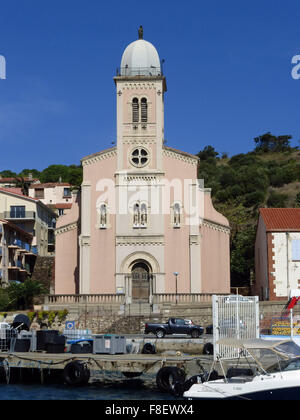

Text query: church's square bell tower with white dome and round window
(114, 26), (167, 173)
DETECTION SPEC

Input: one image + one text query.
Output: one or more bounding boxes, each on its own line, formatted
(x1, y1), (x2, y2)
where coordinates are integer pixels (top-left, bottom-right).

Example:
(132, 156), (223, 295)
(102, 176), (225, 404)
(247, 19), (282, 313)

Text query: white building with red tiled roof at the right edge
(255, 208), (300, 301)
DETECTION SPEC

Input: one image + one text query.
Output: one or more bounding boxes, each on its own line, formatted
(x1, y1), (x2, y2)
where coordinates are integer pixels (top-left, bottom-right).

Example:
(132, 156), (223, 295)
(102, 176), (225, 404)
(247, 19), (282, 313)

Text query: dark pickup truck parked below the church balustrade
(145, 318), (204, 338)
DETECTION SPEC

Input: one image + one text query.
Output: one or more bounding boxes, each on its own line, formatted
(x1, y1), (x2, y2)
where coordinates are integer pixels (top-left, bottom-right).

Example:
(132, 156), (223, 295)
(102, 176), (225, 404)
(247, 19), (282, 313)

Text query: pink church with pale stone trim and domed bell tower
(55, 28), (230, 304)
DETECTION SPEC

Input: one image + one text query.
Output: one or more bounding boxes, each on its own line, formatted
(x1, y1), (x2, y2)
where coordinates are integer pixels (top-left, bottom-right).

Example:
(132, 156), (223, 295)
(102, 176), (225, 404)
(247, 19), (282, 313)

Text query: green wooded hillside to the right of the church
(198, 133), (300, 287)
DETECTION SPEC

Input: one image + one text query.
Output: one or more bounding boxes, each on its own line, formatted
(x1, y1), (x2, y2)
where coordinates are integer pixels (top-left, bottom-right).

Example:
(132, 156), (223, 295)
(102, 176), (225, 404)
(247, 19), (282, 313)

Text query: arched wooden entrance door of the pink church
(131, 261), (151, 302)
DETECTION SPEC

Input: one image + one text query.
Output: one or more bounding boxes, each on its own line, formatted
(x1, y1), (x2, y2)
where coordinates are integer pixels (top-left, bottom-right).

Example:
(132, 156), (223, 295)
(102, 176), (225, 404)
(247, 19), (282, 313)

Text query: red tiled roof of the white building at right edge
(259, 208), (300, 231)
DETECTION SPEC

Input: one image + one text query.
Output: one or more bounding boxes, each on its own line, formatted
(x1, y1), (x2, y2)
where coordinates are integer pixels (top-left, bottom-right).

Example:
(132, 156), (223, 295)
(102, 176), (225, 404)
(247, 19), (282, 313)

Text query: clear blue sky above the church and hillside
(0, 0), (300, 172)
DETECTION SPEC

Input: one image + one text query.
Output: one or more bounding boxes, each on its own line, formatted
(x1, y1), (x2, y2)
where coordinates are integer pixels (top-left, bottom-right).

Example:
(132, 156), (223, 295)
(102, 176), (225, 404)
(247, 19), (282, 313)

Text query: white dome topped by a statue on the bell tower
(121, 26), (161, 76)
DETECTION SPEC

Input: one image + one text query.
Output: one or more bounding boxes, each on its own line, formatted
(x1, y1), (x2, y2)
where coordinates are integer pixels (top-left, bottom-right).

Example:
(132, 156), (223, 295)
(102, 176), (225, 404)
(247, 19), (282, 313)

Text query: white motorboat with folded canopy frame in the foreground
(183, 339), (300, 400)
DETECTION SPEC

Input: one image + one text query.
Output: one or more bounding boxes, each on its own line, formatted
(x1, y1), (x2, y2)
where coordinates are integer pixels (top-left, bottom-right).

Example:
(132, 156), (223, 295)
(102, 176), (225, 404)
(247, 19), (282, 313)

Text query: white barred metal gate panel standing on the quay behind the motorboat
(213, 295), (259, 360)
